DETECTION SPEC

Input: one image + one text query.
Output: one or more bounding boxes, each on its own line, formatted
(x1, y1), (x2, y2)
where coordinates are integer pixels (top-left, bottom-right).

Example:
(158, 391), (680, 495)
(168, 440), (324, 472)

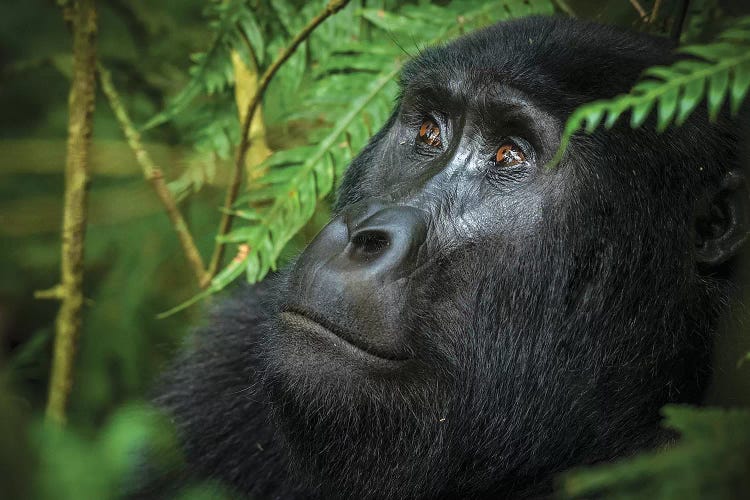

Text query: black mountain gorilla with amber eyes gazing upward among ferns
(151, 18), (748, 499)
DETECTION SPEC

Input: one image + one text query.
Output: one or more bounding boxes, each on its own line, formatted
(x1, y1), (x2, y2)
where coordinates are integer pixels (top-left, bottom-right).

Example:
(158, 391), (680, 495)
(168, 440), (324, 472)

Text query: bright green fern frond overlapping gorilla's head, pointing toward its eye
(548, 17), (750, 168)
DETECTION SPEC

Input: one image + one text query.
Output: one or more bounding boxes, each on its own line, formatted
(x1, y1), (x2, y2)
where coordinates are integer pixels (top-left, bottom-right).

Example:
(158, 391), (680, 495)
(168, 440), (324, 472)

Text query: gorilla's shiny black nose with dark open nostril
(344, 205), (426, 277)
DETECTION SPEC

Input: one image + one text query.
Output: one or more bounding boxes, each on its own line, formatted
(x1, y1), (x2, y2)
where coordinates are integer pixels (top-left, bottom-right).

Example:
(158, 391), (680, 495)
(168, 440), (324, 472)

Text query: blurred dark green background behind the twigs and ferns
(0, 0), (750, 498)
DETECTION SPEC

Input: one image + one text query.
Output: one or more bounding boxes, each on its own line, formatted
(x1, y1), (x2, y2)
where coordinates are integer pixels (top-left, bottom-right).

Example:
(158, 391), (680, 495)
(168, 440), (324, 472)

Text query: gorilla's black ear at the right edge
(695, 171), (750, 266)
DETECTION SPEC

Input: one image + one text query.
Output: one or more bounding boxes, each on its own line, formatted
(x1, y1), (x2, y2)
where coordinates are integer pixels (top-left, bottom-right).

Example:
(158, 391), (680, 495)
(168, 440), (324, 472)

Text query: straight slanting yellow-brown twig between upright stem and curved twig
(97, 64), (206, 284)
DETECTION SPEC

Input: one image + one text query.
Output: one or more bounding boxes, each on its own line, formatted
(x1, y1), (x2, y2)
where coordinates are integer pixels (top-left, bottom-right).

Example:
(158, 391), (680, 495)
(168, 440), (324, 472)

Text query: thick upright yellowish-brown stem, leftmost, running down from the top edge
(42, 0), (97, 424)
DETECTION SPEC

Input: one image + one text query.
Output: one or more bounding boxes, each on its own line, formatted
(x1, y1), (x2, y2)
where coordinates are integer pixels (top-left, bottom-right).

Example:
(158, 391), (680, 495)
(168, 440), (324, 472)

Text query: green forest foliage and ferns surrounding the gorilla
(0, 0), (750, 499)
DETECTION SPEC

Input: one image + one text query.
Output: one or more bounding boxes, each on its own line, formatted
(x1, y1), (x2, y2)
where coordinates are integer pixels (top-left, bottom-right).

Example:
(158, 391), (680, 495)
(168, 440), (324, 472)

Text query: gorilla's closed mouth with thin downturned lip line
(279, 306), (407, 363)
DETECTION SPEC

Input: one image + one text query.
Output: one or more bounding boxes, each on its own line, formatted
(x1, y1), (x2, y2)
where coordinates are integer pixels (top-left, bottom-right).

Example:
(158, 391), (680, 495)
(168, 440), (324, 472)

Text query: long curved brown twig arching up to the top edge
(203, 0), (349, 287)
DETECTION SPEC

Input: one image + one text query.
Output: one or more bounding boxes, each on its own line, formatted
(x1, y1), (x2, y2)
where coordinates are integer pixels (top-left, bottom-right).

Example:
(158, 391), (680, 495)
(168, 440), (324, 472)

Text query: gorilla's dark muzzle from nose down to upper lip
(287, 203), (427, 359)
